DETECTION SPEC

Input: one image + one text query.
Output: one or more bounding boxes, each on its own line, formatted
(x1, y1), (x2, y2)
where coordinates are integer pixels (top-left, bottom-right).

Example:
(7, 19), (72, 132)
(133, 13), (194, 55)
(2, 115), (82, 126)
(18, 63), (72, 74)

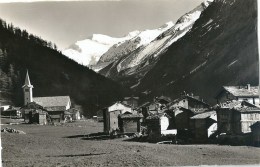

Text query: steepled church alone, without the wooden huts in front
(22, 71), (71, 122)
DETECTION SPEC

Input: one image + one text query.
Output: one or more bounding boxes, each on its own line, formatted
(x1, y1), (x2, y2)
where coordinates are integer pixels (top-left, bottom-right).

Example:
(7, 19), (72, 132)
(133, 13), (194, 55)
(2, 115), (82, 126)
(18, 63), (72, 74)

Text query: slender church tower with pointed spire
(22, 71), (33, 105)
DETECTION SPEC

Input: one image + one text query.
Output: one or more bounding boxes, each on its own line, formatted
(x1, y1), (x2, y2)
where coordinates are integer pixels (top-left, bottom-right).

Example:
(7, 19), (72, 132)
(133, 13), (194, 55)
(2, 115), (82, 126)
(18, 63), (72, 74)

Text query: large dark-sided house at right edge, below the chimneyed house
(216, 100), (260, 135)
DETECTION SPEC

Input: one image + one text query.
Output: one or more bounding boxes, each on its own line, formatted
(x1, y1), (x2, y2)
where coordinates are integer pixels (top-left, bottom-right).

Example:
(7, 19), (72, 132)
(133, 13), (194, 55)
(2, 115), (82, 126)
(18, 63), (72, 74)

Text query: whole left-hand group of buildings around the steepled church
(1, 71), (81, 125)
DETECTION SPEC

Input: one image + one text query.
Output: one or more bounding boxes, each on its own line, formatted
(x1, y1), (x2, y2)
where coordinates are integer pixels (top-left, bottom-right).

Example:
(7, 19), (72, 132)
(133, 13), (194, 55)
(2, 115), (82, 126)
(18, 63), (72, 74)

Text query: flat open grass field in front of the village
(1, 119), (260, 167)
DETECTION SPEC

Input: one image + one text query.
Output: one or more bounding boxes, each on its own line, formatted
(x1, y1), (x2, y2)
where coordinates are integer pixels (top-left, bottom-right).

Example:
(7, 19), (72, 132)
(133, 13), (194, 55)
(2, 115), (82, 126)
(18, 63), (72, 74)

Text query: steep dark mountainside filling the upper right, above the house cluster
(136, 0), (258, 104)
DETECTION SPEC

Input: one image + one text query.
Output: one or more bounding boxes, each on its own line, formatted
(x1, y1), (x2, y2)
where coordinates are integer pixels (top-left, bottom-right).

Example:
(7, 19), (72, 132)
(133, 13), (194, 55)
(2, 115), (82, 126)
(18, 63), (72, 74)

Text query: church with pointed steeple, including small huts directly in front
(22, 71), (71, 124)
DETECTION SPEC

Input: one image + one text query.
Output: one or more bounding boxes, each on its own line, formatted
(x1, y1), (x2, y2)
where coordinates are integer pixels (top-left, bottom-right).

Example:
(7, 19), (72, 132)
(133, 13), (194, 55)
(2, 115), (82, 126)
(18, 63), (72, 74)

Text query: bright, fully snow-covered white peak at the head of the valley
(62, 31), (140, 66)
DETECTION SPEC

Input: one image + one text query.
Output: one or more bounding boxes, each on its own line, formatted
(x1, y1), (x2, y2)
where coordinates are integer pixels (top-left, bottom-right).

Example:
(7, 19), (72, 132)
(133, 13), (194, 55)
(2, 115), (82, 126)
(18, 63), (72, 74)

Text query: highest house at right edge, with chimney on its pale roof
(215, 84), (259, 104)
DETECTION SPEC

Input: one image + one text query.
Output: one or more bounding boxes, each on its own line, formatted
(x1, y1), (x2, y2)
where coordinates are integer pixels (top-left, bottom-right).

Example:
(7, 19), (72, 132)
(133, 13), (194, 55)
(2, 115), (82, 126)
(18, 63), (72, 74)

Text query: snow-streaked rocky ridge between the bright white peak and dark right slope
(98, 0), (213, 79)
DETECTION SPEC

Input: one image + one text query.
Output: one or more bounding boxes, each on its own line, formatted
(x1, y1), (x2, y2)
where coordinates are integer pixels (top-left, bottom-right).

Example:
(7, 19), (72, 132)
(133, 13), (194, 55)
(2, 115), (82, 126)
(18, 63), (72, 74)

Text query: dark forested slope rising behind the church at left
(0, 20), (128, 116)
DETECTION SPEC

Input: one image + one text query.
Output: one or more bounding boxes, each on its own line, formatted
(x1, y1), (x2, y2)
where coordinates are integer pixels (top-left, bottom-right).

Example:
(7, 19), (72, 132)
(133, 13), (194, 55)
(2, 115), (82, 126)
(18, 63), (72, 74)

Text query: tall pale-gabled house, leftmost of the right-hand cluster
(102, 102), (133, 133)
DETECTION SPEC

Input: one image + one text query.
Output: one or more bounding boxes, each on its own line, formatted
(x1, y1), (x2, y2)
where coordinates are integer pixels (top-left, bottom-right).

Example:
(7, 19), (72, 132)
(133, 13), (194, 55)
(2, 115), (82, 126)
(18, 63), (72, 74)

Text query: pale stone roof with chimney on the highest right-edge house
(223, 86), (259, 97)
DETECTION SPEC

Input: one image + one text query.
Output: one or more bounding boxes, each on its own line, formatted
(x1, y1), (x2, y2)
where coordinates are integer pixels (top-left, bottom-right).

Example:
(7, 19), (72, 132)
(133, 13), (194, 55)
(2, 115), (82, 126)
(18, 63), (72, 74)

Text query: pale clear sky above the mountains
(0, 0), (204, 50)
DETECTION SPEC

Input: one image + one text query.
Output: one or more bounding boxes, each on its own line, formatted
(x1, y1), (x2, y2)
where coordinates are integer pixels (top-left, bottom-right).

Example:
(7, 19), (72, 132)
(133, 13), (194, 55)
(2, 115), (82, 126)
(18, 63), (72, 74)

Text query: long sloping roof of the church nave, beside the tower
(33, 96), (70, 111)
